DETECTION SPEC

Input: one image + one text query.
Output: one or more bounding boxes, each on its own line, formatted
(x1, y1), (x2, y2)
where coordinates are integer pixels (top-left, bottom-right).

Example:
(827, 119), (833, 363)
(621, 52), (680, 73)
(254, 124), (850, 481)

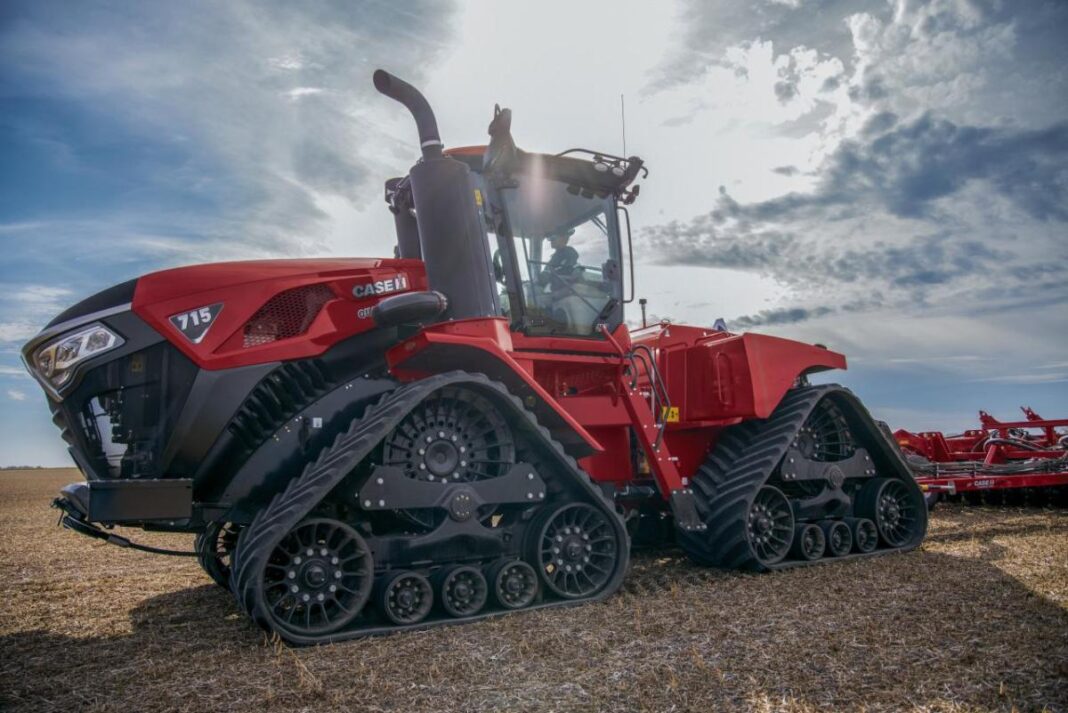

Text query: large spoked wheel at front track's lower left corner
(263, 518), (374, 636)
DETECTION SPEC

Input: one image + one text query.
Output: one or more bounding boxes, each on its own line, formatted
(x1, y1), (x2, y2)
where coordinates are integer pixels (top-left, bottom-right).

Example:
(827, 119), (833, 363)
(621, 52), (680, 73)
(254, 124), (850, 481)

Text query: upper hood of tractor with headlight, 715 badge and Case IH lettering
(22, 258), (426, 400)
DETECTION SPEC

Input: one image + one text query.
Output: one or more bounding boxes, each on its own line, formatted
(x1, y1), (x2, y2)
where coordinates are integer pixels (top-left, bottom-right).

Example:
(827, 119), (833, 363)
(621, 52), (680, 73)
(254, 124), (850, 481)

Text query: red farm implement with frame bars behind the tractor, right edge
(894, 407), (1068, 493)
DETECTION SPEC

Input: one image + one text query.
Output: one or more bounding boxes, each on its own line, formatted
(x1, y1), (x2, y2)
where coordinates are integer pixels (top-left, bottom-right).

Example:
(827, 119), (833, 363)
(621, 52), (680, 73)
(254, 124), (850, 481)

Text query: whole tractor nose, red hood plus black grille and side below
(22, 252), (426, 479)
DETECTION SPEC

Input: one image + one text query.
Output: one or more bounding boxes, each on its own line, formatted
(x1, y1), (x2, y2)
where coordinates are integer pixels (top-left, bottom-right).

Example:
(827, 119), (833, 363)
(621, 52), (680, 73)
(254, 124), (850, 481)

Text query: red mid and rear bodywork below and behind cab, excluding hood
(387, 318), (846, 492)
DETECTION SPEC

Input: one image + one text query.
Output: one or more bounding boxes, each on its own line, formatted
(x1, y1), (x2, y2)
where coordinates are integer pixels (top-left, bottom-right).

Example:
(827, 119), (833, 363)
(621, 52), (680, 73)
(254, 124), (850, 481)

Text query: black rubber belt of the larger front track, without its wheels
(231, 371), (629, 645)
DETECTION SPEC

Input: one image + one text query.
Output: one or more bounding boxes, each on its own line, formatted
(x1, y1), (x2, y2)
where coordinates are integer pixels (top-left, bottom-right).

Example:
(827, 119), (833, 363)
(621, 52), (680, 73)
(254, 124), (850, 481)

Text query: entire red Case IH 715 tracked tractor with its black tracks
(23, 70), (927, 644)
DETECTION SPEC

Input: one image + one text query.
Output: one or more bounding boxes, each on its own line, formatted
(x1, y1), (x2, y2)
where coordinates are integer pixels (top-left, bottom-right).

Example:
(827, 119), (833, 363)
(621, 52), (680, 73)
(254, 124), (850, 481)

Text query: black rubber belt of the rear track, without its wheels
(677, 384), (926, 571)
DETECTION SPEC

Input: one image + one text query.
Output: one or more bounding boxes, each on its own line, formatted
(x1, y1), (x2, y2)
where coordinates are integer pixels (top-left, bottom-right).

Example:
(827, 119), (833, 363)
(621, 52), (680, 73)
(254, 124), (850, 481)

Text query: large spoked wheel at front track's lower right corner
(534, 503), (624, 599)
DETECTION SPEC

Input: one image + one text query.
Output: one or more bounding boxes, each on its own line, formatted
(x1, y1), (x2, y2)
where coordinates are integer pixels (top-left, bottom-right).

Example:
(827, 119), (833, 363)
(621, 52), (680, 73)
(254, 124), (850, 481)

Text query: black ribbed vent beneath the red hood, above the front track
(229, 359), (335, 450)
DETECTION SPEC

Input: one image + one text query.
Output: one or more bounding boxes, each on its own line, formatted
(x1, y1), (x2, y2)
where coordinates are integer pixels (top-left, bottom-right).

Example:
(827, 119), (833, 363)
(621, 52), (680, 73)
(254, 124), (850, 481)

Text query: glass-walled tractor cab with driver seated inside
(387, 91), (648, 338)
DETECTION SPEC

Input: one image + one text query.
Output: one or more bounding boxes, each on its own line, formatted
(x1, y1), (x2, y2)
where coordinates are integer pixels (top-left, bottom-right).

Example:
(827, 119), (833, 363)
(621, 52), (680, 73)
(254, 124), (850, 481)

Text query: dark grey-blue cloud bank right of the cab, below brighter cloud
(640, 116), (1068, 328)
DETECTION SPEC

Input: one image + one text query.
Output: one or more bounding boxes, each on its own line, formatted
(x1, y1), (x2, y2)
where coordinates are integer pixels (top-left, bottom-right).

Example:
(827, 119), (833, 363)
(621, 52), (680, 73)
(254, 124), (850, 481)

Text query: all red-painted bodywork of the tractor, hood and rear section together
(134, 258), (846, 493)
